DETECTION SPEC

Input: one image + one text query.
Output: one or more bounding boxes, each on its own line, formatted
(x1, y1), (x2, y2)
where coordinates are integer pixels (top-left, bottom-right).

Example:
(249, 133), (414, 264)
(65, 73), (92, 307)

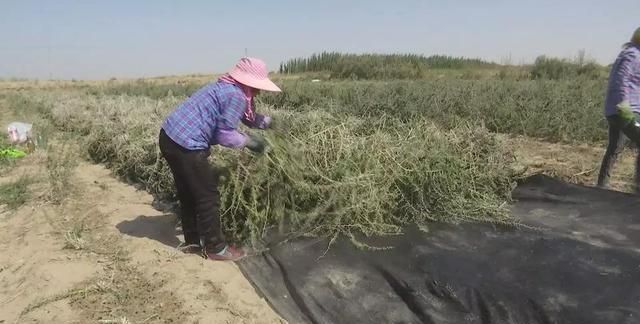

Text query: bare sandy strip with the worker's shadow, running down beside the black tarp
(72, 164), (281, 323)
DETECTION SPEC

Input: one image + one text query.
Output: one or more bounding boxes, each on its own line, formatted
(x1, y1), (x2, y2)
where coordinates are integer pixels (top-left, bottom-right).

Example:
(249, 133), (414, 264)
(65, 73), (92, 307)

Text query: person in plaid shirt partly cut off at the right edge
(598, 28), (640, 193)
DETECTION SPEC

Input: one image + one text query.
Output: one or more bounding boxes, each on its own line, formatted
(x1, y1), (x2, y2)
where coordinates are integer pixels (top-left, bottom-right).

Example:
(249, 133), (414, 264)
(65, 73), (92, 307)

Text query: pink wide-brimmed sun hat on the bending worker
(229, 57), (282, 92)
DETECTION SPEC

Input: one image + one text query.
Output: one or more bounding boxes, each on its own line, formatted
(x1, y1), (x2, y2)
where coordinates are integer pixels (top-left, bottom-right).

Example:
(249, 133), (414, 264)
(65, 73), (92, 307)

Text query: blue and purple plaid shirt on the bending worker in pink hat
(162, 81), (270, 150)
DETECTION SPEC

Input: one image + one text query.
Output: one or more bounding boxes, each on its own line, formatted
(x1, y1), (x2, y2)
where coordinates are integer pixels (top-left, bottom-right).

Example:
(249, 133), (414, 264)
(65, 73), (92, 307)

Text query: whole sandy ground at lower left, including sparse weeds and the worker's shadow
(0, 153), (283, 324)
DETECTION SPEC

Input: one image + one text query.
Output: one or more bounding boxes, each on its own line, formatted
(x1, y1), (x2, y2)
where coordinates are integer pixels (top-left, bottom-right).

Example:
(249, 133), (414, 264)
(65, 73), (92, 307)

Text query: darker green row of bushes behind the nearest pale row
(88, 79), (607, 142)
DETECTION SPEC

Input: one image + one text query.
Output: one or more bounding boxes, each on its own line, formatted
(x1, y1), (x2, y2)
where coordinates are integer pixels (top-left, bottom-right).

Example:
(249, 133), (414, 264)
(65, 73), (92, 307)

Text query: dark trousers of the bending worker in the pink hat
(159, 130), (225, 251)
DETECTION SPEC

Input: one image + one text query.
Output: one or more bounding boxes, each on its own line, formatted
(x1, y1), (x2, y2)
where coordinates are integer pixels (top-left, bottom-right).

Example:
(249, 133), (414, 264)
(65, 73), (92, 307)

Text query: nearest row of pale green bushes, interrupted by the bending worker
(17, 87), (513, 242)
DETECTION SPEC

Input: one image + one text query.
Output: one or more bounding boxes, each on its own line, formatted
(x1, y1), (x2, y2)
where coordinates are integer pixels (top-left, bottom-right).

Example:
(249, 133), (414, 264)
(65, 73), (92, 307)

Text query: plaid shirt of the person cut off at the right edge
(605, 44), (640, 116)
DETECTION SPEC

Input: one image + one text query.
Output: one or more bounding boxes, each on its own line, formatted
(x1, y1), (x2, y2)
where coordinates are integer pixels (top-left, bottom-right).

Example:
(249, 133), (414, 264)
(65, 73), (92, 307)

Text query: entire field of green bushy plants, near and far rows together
(2, 52), (606, 246)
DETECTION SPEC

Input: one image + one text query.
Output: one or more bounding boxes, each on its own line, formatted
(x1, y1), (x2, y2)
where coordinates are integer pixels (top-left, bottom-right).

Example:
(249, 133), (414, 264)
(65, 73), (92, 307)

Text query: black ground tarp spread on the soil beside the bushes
(240, 176), (640, 324)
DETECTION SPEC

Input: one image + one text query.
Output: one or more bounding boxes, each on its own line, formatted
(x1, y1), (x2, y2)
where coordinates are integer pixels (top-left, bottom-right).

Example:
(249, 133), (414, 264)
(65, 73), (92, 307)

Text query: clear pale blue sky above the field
(0, 0), (640, 79)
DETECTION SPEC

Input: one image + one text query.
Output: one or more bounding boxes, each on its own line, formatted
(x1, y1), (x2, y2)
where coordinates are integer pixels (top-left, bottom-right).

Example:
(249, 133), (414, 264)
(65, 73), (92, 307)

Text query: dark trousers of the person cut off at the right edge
(598, 113), (640, 192)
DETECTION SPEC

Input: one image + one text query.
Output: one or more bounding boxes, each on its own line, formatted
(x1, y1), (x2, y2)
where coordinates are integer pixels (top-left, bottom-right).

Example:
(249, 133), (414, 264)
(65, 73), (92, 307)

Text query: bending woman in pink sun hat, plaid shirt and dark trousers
(159, 57), (281, 261)
